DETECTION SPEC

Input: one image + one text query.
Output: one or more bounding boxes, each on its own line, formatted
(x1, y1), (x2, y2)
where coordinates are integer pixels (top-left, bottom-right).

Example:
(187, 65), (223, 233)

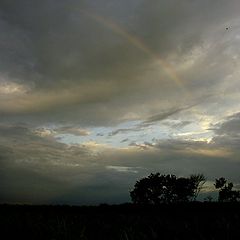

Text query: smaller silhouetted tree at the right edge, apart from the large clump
(214, 177), (240, 202)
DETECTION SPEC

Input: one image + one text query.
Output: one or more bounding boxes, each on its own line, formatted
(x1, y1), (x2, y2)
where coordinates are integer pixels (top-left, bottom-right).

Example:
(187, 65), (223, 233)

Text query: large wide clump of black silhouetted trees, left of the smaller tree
(130, 173), (205, 205)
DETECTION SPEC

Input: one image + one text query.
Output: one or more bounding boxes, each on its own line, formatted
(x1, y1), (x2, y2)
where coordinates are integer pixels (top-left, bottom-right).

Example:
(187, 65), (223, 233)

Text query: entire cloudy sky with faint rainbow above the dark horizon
(0, 0), (240, 205)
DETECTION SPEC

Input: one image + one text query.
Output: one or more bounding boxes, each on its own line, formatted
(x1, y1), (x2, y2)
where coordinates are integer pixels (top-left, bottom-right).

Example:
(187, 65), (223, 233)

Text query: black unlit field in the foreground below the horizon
(0, 203), (240, 240)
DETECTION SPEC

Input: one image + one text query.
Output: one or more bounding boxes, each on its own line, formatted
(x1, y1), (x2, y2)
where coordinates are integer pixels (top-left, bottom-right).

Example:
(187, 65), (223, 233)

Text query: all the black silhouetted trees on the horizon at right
(130, 173), (240, 205)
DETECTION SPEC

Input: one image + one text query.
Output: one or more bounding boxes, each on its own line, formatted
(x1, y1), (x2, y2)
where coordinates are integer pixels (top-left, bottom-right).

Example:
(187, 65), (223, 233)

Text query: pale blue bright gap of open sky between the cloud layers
(55, 120), (213, 148)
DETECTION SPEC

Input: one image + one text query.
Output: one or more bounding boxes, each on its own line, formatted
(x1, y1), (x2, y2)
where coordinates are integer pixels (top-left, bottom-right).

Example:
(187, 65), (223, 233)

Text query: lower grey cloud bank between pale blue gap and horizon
(0, 122), (240, 204)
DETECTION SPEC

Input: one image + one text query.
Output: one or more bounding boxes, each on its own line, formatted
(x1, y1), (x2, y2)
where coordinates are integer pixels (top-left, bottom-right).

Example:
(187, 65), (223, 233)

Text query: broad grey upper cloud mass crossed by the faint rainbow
(0, 0), (239, 125)
